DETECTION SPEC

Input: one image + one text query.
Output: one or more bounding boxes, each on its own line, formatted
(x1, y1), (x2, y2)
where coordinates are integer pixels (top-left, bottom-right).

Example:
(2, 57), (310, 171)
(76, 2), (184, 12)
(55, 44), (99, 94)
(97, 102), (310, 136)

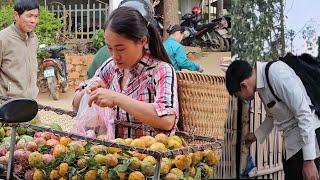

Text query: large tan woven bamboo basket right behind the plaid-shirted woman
(177, 72), (229, 139)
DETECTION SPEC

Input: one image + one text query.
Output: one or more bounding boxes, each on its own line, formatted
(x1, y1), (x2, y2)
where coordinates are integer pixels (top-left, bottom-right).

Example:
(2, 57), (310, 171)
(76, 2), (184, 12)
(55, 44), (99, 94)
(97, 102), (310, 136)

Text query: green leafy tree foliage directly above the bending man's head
(231, 0), (281, 63)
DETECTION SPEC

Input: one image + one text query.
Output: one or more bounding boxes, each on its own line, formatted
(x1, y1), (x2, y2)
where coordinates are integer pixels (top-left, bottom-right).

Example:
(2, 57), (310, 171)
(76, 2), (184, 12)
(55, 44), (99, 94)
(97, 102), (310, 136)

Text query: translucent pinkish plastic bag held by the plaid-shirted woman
(73, 90), (115, 140)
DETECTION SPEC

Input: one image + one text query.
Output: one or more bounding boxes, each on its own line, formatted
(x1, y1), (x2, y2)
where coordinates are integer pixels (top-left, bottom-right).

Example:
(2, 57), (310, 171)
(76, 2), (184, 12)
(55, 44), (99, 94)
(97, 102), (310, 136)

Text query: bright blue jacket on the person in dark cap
(163, 36), (200, 71)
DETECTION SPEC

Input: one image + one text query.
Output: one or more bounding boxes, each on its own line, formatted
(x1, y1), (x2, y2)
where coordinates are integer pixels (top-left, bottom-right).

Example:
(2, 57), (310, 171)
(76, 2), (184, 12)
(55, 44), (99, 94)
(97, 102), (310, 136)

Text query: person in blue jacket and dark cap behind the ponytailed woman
(163, 25), (203, 72)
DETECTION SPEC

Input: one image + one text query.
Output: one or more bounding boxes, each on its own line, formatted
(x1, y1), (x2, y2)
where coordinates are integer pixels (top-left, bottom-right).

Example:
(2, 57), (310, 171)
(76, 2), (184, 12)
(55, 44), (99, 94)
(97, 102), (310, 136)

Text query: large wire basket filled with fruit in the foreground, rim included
(0, 96), (223, 179)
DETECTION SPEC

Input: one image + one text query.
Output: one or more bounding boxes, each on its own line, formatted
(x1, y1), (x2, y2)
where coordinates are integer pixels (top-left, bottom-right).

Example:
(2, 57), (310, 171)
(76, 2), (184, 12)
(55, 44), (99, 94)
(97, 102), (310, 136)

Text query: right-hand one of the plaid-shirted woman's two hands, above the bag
(89, 88), (118, 108)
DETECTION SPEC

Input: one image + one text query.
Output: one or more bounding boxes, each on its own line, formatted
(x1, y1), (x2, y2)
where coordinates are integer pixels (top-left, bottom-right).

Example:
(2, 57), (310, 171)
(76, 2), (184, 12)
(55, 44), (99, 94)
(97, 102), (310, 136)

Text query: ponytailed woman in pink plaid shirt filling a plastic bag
(73, 7), (179, 138)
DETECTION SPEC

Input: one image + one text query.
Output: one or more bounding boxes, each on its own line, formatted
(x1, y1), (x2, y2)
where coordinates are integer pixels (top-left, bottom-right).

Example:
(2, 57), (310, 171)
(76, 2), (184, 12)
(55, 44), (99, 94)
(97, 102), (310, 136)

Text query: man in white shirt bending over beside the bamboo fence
(226, 60), (320, 180)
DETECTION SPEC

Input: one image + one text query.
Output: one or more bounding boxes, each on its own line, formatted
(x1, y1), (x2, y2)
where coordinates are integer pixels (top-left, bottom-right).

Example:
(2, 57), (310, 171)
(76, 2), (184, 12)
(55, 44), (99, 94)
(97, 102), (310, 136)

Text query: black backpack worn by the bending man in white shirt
(265, 53), (320, 117)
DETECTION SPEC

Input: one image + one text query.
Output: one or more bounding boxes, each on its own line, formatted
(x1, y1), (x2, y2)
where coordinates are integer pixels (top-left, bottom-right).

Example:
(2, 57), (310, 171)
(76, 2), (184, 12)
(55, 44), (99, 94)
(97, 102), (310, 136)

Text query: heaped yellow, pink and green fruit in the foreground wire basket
(0, 124), (219, 180)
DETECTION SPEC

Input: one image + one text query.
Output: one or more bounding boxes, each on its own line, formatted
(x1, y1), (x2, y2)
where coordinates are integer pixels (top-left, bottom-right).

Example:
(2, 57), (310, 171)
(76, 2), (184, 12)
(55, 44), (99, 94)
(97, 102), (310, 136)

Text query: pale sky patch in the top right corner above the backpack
(284, 0), (320, 56)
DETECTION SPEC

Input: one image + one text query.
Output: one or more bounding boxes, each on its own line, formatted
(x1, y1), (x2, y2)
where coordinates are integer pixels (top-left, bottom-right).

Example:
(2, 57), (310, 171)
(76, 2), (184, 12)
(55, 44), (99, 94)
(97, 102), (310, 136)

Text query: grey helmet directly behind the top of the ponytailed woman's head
(119, 0), (153, 22)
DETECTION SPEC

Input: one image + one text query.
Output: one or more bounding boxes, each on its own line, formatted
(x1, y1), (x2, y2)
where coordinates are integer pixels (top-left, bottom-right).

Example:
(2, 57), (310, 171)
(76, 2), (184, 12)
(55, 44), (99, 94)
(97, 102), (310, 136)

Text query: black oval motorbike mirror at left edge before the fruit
(0, 98), (38, 123)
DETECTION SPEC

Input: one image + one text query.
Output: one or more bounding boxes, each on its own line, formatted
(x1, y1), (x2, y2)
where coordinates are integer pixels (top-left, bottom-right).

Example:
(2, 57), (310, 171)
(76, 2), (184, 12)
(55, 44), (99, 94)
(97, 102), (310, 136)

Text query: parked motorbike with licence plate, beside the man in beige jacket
(40, 45), (68, 100)
